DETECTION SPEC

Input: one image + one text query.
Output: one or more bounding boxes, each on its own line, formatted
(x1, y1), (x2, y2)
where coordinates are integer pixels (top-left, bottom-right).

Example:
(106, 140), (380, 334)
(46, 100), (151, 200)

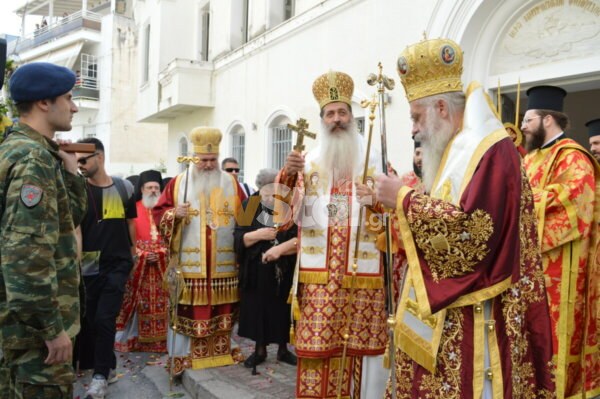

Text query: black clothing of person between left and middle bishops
(234, 192), (298, 345)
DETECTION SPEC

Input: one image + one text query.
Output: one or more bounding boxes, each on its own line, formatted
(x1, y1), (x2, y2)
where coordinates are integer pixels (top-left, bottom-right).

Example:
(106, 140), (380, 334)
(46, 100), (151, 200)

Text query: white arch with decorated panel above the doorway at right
(427, 0), (600, 148)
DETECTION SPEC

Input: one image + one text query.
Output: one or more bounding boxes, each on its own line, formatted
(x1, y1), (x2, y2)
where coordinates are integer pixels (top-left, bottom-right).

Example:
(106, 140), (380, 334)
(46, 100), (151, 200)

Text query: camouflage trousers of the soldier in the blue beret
(0, 348), (75, 399)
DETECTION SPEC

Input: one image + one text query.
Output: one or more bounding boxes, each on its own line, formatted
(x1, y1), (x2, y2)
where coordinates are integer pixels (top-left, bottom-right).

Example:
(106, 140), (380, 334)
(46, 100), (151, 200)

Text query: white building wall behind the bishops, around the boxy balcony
(137, 0), (435, 182)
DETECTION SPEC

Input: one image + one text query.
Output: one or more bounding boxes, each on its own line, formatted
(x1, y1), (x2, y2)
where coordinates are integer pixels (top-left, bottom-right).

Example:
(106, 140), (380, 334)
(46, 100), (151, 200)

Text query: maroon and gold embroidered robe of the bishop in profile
(386, 85), (554, 399)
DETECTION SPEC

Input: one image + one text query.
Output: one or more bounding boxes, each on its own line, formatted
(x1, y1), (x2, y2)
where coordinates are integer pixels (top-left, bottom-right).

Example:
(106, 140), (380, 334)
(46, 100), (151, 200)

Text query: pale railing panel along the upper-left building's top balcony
(8, 11), (102, 54)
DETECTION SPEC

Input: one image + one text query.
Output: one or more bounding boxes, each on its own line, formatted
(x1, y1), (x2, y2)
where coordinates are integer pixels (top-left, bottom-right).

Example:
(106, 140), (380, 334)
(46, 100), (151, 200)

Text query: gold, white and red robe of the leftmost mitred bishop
(153, 173), (243, 373)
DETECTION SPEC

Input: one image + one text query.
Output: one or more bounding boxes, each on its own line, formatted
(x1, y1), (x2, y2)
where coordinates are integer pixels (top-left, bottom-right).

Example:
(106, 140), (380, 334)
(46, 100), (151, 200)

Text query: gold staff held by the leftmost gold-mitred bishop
(166, 156), (200, 389)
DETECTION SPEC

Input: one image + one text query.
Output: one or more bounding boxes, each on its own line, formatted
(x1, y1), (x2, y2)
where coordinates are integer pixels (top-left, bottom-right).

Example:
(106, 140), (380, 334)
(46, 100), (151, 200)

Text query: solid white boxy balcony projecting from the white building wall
(154, 58), (214, 119)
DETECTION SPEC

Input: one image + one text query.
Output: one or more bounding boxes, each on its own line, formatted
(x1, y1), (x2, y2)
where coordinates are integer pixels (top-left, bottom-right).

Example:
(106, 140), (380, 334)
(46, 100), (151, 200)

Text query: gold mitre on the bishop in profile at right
(397, 39), (463, 102)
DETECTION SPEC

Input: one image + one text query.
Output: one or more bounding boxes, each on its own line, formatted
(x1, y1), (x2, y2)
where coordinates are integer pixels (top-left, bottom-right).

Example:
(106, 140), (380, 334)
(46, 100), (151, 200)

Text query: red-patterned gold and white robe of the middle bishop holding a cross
(278, 138), (387, 398)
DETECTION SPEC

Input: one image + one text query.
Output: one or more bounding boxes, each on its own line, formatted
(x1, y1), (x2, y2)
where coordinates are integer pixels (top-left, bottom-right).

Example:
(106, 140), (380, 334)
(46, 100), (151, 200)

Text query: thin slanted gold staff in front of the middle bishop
(336, 94), (378, 399)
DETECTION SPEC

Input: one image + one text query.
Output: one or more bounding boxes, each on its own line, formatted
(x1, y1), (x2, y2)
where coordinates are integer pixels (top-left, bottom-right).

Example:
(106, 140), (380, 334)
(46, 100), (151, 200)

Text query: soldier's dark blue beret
(9, 62), (75, 103)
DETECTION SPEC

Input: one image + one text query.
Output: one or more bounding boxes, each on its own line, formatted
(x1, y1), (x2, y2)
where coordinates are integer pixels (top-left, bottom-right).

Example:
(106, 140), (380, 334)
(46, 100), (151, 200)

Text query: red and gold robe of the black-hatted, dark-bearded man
(524, 139), (600, 399)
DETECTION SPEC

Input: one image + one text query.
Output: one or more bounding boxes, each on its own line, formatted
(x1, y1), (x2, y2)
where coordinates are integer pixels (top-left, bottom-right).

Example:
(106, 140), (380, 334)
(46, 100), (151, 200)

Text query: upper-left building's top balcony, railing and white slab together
(8, 11), (101, 63)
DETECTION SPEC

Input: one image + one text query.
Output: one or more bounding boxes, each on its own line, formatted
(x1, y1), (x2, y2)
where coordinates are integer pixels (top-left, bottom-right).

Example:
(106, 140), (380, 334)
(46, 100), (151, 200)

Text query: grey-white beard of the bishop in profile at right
(415, 107), (454, 194)
